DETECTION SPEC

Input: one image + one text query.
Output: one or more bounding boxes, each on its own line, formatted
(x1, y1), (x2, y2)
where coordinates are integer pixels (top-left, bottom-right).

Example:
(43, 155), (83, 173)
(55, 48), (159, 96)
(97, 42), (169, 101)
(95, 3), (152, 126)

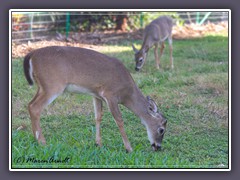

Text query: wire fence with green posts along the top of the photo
(11, 11), (229, 42)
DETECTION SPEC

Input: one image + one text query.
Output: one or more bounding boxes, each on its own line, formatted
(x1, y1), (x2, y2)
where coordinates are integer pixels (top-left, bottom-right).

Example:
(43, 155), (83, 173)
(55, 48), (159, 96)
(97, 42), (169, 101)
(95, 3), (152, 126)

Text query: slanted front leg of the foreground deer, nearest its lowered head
(107, 98), (132, 152)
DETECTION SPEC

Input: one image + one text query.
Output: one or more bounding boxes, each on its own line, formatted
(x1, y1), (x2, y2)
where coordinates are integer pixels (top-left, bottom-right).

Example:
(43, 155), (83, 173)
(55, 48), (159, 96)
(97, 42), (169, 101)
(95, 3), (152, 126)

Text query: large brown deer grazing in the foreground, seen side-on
(23, 46), (167, 152)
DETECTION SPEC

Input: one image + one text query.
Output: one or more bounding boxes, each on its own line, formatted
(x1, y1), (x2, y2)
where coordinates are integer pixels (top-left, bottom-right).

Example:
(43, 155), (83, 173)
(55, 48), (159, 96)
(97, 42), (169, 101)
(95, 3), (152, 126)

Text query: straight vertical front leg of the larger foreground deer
(93, 97), (102, 146)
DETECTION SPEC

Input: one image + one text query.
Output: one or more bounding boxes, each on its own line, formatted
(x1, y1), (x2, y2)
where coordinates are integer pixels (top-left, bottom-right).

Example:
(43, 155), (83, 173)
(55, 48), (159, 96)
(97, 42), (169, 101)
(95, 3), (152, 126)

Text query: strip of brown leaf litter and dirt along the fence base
(12, 22), (228, 58)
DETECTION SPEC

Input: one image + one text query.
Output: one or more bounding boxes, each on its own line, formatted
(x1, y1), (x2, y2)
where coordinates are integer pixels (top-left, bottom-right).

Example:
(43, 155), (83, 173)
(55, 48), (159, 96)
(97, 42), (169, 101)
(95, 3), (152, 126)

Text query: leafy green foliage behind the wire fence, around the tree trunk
(57, 12), (184, 32)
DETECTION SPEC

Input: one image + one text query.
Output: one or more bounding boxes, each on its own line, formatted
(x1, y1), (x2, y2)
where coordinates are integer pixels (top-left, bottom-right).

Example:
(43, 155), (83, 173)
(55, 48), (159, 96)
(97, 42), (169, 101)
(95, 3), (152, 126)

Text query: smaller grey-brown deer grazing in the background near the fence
(132, 16), (174, 71)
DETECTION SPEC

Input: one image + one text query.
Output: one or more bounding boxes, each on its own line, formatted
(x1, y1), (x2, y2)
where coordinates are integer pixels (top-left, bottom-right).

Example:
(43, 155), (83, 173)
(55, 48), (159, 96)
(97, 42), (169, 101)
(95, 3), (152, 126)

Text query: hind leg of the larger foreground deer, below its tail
(28, 88), (60, 145)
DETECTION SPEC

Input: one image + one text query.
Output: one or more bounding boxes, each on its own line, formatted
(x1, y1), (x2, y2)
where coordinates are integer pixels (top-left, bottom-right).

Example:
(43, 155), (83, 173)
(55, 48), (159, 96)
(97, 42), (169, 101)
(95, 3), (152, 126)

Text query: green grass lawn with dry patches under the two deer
(11, 33), (229, 168)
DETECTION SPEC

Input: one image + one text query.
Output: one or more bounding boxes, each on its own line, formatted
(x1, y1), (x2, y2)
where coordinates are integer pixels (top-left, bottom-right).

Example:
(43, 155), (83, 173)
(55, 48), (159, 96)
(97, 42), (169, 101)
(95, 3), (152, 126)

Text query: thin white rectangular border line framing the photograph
(9, 9), (231, 171)
